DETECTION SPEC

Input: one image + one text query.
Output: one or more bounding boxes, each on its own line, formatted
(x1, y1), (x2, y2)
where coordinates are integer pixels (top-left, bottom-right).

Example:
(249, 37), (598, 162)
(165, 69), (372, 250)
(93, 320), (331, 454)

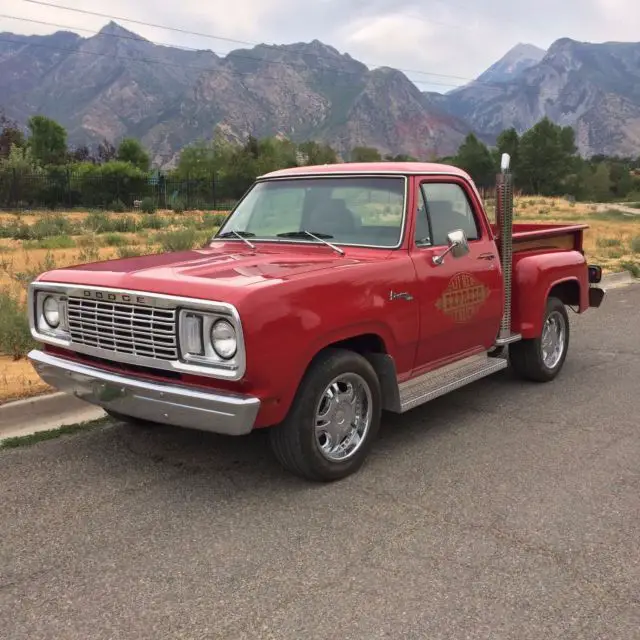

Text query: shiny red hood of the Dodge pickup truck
(39, 243), (387, 302)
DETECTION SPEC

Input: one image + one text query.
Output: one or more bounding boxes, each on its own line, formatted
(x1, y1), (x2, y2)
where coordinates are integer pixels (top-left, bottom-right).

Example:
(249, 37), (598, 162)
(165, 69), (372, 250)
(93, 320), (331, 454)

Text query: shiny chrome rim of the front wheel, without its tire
(315, 373), (373, 462)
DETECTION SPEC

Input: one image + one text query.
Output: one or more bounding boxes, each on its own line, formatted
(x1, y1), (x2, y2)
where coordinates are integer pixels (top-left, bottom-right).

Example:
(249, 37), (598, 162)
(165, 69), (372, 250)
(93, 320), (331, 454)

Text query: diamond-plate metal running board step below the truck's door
(399, 353), (508, 413)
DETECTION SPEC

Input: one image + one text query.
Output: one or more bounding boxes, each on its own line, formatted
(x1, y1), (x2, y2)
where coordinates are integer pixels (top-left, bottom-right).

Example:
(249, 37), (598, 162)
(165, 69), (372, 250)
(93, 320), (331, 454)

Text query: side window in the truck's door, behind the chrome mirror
(422, 182), (480, 245)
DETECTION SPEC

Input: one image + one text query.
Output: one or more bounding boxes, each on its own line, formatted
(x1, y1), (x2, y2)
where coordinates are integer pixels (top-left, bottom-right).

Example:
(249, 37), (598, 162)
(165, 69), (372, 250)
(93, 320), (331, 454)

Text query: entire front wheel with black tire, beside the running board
(269, 349), (382, 482)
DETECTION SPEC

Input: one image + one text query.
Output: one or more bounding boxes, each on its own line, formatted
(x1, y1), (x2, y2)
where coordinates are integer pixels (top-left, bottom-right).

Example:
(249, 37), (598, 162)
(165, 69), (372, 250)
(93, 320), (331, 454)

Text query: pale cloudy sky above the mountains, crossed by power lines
(0, 0), (640, 92)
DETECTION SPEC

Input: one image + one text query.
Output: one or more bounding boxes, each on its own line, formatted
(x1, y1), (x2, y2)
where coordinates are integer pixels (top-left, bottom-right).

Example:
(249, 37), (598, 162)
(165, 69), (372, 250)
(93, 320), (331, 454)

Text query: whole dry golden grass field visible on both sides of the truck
(0, 197), (640, 404)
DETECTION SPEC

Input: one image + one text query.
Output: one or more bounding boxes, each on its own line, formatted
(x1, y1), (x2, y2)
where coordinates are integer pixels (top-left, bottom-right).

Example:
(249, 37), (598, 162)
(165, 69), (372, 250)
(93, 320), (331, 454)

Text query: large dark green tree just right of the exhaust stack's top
(518, 117), (579, 196)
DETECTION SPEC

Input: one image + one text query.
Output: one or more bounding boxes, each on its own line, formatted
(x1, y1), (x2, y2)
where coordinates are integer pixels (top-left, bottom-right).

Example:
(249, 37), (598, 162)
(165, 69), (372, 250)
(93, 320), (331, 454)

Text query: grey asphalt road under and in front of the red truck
(0, 286), (640, 640)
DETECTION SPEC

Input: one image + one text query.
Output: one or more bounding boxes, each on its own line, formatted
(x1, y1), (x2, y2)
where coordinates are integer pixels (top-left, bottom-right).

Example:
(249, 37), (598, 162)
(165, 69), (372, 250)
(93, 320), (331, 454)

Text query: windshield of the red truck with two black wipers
(216, 176), (405, 247)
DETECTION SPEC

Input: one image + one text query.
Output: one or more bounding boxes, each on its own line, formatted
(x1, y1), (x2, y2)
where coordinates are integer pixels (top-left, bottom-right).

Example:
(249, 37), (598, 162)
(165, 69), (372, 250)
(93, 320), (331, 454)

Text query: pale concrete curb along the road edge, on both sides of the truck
(0, 271), (640, 440)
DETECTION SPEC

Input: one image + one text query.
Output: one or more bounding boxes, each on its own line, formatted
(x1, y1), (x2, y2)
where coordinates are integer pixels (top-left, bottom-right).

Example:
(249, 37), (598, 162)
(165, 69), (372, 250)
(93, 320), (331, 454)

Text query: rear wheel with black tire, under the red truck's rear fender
(509, 297), (570, 382)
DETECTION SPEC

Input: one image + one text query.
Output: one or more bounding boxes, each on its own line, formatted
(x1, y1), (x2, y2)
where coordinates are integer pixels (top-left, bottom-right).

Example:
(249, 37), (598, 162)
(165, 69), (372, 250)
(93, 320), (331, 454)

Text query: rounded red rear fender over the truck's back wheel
(511, 251), (589, 339)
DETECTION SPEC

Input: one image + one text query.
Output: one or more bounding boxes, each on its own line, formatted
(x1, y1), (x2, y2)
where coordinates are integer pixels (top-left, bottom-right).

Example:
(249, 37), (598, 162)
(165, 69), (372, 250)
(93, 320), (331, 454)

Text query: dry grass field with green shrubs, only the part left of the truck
(0, 211), (226, 404)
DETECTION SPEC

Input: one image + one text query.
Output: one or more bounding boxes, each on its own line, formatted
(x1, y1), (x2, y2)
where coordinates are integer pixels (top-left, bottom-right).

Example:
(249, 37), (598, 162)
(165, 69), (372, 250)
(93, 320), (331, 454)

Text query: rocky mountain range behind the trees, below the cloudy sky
(0, 22), (640, 166)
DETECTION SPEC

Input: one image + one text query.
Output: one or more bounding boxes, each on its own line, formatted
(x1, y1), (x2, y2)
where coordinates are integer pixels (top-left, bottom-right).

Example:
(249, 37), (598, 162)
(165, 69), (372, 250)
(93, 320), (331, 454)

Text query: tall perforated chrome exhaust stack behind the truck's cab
(496, 153), (522, 346)
